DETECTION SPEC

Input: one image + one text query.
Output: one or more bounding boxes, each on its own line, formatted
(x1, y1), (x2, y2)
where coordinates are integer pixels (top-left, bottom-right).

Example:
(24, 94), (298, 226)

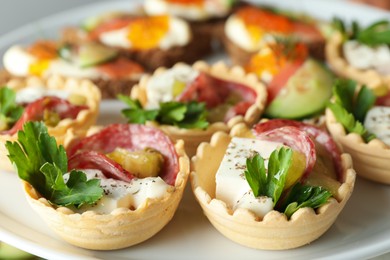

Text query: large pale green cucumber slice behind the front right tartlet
(265, 59), (334, 119)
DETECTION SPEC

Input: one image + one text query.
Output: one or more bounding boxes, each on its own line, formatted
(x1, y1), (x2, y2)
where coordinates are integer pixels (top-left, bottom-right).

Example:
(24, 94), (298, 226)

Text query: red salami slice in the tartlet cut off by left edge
(1, 96), (88, 135)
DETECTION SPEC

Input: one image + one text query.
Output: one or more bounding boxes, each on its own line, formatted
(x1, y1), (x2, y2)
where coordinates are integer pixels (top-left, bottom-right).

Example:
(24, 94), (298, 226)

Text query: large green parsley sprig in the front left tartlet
(5, 122), (103, 207)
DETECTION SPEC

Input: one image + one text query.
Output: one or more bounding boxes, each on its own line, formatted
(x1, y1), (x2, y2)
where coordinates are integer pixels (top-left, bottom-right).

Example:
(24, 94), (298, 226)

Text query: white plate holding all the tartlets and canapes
(0, 0), (390, 259)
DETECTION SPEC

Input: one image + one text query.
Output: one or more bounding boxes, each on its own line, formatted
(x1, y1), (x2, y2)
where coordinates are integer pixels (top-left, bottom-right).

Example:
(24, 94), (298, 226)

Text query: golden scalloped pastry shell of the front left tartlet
(24, 138), (189, 250)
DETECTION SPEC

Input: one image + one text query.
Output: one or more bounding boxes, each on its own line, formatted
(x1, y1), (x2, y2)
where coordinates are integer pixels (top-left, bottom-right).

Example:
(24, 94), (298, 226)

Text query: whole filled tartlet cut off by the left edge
(0, 76), (101, 171)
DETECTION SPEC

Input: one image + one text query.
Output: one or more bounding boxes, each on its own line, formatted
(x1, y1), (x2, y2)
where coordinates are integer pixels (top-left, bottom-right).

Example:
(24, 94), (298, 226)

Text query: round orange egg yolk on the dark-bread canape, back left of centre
(128, 15), (169, 50)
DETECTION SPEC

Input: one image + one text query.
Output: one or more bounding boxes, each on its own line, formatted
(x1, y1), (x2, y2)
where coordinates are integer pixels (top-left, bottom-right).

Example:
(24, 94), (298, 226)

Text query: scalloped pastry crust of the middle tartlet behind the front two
(131, 61), (267, 157)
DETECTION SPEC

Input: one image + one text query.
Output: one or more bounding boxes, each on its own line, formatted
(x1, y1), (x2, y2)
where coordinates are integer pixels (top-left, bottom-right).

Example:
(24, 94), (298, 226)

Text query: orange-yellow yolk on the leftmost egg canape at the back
(27, 40), (58, 76)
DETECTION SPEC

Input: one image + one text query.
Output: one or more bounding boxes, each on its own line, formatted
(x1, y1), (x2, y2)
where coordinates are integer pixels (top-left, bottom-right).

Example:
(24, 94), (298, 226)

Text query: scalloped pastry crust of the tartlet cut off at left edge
(0, 76), (101, 171)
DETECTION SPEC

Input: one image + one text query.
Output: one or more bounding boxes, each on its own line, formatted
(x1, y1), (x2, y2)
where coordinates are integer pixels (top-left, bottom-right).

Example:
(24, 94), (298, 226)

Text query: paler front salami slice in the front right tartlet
(255, 126), (317, 179)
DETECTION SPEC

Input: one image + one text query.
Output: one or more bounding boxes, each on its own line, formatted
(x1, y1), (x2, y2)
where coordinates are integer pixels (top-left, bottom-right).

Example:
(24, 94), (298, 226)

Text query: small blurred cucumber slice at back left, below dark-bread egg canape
(78, 43), (118, 68)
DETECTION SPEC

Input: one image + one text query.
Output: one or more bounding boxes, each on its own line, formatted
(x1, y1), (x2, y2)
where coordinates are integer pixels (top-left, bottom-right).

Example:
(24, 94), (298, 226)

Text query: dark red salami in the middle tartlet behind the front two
(178, 72), (257, 108)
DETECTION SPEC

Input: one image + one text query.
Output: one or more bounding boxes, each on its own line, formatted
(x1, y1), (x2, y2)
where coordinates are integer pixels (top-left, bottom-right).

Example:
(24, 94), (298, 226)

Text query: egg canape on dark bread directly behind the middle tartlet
(63, 12), (211, 71)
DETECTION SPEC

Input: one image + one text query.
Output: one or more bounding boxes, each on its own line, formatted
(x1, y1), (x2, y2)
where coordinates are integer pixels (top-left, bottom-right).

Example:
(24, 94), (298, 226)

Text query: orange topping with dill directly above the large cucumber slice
(245, 43), (308, 76)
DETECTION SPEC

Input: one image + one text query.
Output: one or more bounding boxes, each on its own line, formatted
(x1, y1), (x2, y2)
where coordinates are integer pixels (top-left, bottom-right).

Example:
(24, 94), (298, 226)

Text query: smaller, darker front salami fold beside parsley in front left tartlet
(68, 151), (134, 182)
